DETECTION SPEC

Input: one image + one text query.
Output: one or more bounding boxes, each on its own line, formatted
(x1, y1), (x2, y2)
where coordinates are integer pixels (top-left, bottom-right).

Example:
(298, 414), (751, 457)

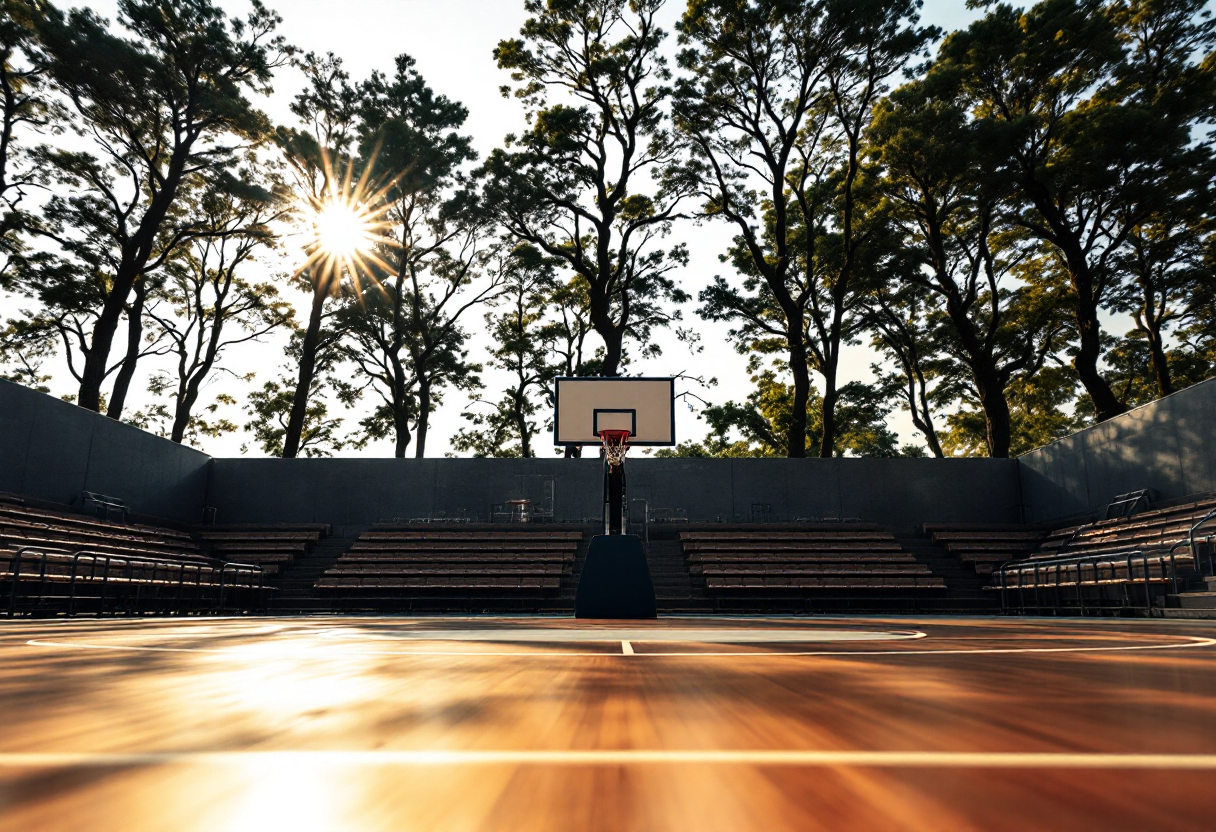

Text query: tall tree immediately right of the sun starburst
(343, 55), (500, 457)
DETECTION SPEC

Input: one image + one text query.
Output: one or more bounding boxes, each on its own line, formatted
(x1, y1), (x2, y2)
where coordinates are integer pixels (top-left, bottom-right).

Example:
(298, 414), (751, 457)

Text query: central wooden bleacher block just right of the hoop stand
(680, 523), (946, 592)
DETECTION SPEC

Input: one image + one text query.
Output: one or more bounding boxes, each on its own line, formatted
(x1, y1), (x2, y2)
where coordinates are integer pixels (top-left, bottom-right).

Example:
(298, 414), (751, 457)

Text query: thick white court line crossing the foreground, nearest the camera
(0, 749), (1216, 771)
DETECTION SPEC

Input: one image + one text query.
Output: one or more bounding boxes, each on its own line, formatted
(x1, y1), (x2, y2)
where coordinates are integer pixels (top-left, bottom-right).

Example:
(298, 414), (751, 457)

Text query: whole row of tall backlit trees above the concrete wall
(0, 0), (1216, 457)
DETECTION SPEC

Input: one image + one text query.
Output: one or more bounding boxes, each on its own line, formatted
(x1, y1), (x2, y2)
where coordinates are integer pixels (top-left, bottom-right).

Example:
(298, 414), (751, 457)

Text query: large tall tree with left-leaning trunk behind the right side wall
(930, 0), (1199, 421)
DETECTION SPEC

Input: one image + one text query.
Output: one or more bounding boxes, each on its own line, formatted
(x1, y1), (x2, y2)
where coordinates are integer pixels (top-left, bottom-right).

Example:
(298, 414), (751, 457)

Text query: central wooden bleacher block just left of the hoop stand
(316, 525), (582, 592)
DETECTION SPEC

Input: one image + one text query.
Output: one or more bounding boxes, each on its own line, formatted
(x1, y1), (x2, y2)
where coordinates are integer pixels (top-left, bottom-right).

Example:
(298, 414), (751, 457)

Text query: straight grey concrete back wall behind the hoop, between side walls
(207, 457), (1020, 530)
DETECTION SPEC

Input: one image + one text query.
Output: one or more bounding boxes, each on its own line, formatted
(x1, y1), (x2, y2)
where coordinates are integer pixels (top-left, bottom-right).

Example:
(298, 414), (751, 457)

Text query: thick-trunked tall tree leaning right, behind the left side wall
(27, 0), (286, 410)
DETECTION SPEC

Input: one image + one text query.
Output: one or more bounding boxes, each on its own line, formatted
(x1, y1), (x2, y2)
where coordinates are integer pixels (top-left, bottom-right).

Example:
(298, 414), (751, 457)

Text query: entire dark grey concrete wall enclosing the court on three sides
(21, 369), (1216, 529)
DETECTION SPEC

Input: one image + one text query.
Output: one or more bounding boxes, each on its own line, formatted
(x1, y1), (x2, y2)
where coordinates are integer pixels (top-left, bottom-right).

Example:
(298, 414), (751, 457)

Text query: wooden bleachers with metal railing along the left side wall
(0, 496), (263, 614)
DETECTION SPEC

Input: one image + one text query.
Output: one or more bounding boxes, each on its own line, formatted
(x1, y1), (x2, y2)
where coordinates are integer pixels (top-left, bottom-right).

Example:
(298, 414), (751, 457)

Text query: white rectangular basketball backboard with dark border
(553, 378), (676, 445)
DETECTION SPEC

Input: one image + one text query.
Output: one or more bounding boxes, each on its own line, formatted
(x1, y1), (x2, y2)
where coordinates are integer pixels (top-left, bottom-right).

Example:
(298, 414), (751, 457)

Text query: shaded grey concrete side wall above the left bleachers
(0, 381), (210, 523)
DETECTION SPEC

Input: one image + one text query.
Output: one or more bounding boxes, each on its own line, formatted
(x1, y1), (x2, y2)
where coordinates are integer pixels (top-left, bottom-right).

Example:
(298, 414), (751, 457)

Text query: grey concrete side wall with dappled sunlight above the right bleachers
(1018, 380), (1216, 522)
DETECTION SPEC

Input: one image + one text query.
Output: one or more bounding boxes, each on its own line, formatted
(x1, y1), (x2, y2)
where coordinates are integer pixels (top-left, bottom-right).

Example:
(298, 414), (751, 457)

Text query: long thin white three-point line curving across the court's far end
(26, 635), (1216, 658)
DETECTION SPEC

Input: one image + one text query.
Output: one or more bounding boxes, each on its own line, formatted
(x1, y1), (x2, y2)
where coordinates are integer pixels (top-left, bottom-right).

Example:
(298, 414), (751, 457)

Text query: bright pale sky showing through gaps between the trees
(54, 0), (978, 456)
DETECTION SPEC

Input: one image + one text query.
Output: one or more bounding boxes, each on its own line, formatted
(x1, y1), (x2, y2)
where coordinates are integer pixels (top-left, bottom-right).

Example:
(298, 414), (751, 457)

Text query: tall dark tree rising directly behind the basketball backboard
(482, 0), (687, 376)
